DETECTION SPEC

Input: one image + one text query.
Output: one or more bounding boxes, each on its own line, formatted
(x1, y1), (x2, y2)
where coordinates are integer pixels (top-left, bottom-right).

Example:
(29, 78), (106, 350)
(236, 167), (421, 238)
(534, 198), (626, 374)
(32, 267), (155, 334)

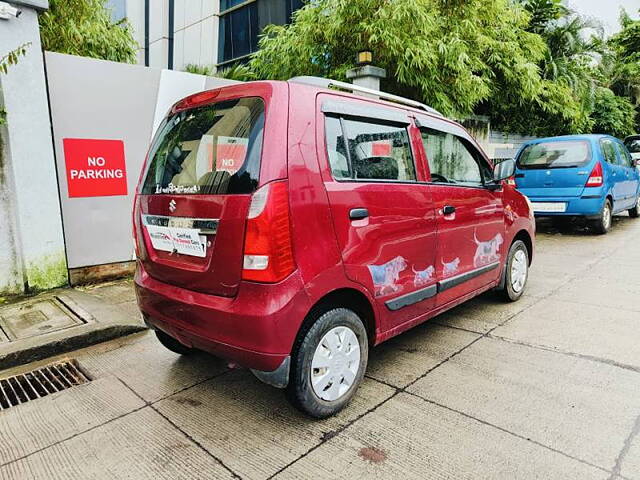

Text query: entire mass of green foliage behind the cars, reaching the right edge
(236, 0), (640, 139)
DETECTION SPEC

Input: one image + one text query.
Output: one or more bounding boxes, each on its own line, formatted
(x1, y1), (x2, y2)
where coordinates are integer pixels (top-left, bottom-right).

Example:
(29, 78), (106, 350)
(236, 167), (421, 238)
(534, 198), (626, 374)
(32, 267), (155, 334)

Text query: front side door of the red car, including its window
(418, 117), (509, 307)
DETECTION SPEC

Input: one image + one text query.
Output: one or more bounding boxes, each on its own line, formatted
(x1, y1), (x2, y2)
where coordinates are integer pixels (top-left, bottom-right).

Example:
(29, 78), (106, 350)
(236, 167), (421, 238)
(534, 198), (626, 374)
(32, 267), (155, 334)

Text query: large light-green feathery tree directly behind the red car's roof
(249, 0), (545, 117)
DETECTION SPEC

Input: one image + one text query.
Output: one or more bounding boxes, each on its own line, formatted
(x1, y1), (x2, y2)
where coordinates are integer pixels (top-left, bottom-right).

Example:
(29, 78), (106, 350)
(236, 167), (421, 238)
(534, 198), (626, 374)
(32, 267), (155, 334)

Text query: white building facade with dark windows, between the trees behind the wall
(107, 0), (304, 70)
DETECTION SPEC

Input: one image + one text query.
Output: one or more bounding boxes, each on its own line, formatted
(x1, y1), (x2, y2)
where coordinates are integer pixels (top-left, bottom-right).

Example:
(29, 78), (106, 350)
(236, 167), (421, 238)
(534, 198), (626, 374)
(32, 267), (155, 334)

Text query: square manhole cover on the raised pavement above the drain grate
(0, 299), (84, 341)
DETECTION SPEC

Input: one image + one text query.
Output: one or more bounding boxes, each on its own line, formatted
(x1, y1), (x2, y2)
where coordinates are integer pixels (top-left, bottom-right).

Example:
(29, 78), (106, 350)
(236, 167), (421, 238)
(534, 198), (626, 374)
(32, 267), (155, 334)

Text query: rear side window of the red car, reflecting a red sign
(326, 116), (416, 181)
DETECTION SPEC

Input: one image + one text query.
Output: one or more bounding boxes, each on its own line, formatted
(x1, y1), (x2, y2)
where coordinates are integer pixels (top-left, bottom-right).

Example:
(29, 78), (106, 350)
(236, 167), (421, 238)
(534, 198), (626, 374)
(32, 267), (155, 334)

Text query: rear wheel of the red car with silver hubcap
(286, 308), (369, 418)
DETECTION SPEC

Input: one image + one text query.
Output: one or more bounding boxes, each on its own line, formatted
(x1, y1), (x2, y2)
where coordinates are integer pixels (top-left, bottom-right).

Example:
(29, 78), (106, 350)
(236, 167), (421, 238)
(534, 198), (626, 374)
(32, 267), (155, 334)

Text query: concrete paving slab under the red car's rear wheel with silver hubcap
(156, 370), (394, 479)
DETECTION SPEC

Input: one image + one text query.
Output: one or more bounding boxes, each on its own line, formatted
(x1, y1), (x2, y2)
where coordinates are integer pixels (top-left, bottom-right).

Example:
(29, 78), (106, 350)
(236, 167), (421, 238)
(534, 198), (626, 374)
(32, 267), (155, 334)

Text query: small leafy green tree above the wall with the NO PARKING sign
(39, 0), (138, 63)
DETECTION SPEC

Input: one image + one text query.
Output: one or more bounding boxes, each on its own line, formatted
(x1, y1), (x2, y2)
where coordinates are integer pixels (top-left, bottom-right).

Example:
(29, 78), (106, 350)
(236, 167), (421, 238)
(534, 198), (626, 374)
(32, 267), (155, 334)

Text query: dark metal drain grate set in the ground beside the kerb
(0, 360), (91, 410)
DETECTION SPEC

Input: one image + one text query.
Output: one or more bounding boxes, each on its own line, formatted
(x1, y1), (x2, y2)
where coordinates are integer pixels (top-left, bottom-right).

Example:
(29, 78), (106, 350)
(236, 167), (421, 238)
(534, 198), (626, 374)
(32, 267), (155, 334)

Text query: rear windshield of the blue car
(517, 140), (591, 169)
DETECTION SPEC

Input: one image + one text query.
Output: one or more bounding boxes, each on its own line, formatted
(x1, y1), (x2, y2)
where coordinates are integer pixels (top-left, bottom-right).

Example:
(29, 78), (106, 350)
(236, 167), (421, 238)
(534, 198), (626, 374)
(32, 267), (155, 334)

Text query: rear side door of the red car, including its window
(318, 95), (437, 331)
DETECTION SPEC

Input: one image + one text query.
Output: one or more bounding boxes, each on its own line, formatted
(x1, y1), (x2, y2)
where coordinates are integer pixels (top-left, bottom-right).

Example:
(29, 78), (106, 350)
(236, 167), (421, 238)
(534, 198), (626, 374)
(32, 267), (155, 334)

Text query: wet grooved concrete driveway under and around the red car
(0, 217), (640, 479)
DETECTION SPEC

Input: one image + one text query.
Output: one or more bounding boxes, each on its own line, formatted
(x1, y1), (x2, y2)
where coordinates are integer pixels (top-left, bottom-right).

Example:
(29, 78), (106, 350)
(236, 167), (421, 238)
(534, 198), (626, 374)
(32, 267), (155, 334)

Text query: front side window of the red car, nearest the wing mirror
(421, 128), (491, 186)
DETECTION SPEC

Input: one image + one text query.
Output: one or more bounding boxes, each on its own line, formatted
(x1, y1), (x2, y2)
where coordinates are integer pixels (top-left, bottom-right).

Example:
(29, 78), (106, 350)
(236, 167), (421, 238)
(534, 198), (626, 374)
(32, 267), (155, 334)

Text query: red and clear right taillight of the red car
(242, 182), (295, 283)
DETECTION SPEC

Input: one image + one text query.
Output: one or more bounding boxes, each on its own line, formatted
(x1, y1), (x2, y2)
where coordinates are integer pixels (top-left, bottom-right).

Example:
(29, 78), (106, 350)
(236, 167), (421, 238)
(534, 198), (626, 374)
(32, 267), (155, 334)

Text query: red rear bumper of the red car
(135, 263), (310, 372)
